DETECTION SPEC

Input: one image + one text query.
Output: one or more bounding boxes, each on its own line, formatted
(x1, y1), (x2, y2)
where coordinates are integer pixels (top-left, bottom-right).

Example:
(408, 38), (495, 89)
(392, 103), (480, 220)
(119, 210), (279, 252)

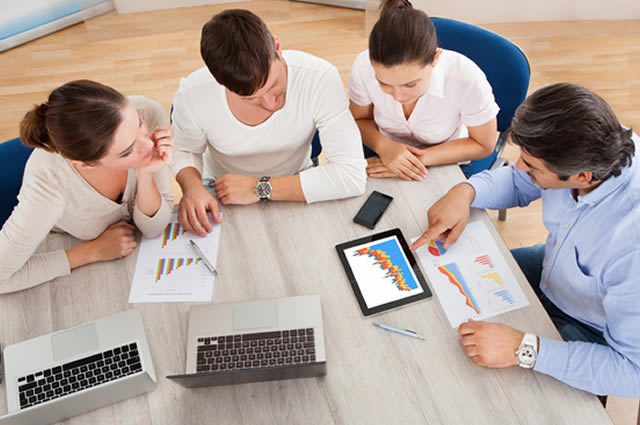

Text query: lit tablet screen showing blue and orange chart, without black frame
(344, 236), (424, 308)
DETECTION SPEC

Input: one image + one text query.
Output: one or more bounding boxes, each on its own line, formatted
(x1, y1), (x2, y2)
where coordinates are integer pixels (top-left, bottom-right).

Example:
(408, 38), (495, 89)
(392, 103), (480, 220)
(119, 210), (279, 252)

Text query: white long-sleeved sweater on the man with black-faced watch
(171, 50), (366, 203)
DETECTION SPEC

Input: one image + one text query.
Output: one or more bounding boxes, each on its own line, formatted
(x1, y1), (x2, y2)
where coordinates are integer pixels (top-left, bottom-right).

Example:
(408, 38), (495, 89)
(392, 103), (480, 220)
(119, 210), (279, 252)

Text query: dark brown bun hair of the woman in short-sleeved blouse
(369, 0), (438, 66)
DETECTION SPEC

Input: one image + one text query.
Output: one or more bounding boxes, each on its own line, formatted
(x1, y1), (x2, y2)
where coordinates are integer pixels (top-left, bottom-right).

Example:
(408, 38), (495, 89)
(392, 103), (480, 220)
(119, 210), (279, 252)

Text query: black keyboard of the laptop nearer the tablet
(196, 328), (316, 372)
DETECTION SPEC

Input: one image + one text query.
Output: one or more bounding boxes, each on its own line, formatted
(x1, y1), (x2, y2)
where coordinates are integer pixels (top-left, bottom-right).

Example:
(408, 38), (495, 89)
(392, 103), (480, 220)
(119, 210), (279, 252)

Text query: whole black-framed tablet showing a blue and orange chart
(336, 229), (431, 316)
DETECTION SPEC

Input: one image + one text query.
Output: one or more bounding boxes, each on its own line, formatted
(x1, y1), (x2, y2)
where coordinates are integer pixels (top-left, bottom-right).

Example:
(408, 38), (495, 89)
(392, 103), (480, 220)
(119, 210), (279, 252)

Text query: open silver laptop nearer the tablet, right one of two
(167, 295), (327, 387)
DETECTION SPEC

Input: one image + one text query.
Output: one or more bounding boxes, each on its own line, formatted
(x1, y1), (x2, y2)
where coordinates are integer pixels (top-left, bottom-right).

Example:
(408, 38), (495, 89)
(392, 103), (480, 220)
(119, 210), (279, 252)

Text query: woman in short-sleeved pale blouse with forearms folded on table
(349, 0), (499, 180)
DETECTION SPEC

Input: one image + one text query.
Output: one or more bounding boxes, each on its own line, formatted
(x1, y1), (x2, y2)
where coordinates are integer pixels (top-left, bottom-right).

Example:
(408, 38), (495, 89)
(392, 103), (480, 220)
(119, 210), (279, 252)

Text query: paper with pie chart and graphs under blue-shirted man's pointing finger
(414, 221), (529, 328)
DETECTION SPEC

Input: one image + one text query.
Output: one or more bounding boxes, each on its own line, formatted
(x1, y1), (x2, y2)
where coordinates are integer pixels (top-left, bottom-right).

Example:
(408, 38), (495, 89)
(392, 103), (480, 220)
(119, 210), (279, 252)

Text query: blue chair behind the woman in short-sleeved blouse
(431, 18), (531, 220)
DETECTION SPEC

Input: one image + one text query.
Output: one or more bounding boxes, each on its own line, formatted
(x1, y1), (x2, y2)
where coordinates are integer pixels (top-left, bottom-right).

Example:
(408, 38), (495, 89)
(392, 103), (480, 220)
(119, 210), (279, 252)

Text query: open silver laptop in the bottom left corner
(0, 310), (156, 425)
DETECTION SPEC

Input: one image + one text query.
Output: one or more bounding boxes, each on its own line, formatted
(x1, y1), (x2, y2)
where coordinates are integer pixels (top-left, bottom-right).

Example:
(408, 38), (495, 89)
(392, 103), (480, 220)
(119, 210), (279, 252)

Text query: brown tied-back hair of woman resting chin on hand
(20, 80), (127, 162)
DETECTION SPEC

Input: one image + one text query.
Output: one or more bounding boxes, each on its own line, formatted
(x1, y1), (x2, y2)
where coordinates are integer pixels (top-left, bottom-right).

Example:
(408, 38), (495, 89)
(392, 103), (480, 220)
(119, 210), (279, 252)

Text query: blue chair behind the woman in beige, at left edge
(0, 138), (33, 227)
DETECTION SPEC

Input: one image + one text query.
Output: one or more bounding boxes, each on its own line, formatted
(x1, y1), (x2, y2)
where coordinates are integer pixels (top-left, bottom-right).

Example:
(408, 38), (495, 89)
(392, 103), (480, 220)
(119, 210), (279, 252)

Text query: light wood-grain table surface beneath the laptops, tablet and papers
(0, 166), (611, 425)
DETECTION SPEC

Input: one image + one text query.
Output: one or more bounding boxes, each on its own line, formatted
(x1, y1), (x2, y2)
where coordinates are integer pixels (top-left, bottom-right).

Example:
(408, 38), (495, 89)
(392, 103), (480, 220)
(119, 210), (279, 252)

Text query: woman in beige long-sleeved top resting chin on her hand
(0, 80), (174, 293)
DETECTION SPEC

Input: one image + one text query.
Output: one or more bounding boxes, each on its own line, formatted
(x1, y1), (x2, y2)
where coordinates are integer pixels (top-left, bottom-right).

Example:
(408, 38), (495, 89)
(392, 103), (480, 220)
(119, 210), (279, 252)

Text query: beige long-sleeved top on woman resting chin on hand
(0, 96), (173, 293)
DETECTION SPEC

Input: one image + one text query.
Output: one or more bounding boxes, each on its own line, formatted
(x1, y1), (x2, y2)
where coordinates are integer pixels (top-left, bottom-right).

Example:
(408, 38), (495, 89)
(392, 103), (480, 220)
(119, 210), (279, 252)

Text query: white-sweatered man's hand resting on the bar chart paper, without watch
(178, 183), (222, 236)
